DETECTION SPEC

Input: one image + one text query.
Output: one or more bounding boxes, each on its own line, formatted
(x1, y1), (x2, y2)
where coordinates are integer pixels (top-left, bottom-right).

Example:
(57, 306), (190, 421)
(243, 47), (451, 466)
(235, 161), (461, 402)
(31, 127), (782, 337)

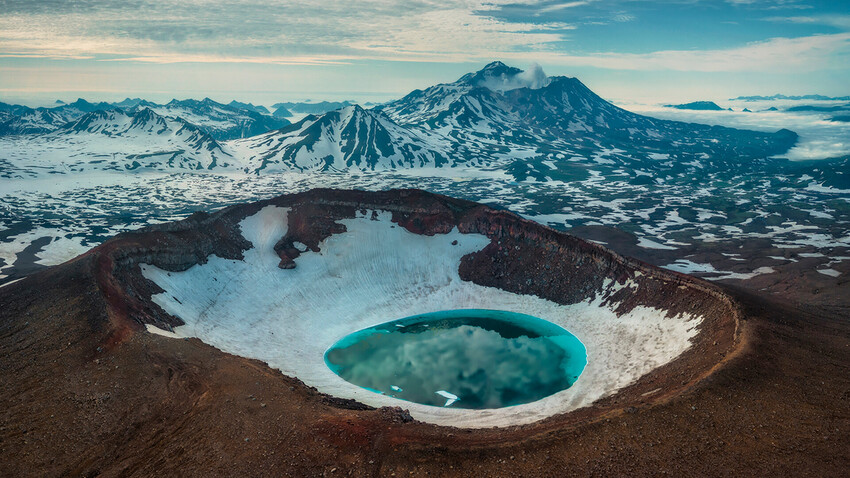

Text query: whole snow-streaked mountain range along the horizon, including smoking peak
(0, 62), (797, 181)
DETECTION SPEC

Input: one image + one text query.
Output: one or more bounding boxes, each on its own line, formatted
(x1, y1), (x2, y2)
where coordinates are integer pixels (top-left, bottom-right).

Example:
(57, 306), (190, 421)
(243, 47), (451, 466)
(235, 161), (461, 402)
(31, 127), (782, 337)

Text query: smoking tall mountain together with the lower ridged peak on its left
(225, 62), (797, 177)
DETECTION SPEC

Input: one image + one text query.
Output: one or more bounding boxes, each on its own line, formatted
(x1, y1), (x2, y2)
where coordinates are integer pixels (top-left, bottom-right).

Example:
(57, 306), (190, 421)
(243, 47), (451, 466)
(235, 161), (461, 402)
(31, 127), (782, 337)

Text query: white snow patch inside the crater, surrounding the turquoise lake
(141, 206), (700, 428)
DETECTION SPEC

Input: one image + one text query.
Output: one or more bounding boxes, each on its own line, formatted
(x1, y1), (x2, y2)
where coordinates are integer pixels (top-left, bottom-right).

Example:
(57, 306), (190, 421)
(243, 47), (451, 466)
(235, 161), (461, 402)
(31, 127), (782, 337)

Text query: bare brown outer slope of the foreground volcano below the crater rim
(0, 189), (850, 476)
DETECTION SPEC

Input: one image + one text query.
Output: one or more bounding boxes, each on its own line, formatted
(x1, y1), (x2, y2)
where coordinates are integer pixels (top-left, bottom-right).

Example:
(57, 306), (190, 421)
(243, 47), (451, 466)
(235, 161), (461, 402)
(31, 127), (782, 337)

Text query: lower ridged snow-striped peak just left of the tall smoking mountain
(228, 105), (456, 172)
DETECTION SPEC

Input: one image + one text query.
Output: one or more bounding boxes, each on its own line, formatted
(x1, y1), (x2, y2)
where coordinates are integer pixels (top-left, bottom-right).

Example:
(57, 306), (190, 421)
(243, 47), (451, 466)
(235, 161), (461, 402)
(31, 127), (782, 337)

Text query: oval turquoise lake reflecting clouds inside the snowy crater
(325, 309), (587, 409)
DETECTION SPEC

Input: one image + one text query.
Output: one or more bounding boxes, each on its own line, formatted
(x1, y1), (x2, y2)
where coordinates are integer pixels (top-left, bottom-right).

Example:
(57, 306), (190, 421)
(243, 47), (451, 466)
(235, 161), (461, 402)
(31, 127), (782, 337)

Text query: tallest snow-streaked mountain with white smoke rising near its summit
(377, 62), (797, 169)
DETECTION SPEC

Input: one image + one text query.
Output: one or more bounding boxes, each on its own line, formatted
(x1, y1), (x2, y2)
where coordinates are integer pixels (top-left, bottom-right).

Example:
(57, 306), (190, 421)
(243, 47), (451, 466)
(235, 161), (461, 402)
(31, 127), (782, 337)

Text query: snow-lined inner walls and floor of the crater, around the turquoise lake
(107, 190), (739, 428)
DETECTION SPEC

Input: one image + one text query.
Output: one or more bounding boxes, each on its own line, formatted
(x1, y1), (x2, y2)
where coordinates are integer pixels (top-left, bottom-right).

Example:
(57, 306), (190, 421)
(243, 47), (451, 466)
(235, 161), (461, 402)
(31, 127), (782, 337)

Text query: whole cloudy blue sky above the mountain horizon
(0, 0), (850, 105)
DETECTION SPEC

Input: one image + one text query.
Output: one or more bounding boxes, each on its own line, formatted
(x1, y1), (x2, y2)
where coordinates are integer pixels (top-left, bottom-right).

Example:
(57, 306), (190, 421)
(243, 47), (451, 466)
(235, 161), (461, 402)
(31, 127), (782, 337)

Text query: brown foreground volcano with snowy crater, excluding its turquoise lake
(0, 190), (850, 476)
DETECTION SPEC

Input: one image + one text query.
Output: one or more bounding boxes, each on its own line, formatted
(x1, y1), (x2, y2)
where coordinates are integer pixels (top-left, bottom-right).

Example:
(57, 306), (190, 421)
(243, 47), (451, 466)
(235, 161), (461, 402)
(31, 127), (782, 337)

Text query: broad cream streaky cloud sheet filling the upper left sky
(0, 0), (573, 62)
